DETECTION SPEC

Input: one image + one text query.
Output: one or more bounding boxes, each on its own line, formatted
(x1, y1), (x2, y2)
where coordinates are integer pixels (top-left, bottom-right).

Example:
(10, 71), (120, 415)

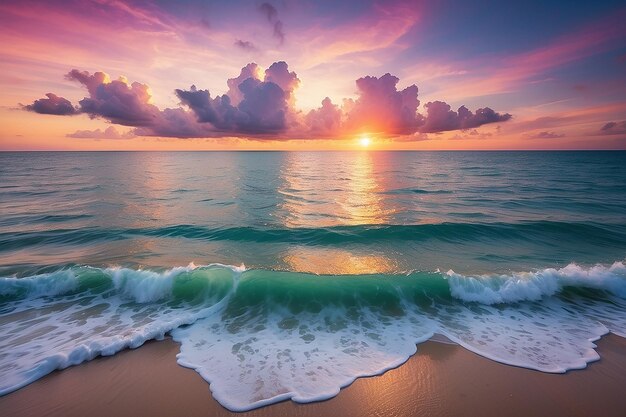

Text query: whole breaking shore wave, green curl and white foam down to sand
(0, 262), (626, 411)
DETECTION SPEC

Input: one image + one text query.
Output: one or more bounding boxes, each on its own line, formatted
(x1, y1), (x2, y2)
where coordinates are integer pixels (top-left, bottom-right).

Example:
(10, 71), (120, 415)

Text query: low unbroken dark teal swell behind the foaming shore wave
(0, 221), (626, 251)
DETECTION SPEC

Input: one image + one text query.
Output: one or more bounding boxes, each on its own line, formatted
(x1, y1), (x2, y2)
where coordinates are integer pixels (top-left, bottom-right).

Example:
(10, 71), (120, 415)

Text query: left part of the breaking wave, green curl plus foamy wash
(0, 264), (241, 395)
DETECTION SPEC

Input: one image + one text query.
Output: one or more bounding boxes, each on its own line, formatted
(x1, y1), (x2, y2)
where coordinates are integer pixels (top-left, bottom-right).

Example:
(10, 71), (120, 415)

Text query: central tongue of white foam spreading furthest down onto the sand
(172, 307), (436, 411)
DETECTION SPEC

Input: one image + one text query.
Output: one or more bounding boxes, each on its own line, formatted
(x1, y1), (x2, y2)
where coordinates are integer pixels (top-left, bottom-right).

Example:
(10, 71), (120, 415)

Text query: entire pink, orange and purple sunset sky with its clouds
(0, 0), (626, 150)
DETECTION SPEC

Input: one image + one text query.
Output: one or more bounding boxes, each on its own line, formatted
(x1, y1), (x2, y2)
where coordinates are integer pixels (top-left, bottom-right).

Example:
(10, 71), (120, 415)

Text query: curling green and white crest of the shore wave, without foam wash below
(0, 261), (626, 305)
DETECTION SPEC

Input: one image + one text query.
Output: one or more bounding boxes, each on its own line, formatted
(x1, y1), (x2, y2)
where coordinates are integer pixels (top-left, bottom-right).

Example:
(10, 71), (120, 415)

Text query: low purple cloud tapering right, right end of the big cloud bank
(420, 101), (511, 133)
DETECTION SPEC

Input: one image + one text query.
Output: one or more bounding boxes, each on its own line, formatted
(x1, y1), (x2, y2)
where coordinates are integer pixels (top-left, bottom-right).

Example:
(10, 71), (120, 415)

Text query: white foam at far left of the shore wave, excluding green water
(0, 265), (241, 395)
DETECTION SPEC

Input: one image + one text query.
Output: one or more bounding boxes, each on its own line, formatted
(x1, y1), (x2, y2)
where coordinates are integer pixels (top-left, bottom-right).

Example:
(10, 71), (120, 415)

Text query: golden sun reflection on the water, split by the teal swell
(275, 152), (397, 274)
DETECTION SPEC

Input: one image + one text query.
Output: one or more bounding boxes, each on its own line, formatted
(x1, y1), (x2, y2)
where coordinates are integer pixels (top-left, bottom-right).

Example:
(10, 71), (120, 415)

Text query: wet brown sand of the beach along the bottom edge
(0, 335), (626, 417)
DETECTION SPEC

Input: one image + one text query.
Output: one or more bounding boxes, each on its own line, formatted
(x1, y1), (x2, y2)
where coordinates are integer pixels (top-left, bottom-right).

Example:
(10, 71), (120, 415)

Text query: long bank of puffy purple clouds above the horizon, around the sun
(24, 61), (511, 141)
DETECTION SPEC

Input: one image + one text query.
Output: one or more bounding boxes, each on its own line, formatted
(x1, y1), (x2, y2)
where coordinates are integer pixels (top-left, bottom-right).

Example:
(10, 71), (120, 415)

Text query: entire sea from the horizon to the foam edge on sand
(0, 152), (626, 411)
